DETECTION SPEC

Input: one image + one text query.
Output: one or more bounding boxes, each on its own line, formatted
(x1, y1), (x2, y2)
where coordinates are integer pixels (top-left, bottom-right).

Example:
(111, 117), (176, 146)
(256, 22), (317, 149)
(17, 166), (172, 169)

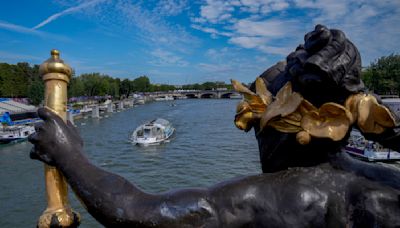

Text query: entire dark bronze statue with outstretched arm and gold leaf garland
(29, 25), (400, 227)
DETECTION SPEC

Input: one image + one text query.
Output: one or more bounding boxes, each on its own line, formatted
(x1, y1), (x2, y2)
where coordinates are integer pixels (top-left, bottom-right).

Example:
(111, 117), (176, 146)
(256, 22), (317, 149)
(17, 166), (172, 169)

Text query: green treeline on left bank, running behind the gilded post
(0, 62), (232, 105)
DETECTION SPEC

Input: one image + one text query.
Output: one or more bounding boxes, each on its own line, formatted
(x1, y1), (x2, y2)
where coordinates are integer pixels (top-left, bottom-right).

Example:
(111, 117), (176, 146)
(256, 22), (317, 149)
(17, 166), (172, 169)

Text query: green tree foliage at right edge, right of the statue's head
(362, 54), (400, 95)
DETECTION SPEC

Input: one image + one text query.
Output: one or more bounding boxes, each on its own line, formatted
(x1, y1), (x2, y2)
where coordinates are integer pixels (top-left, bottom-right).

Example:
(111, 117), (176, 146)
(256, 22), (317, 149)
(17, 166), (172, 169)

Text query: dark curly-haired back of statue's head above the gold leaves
(261, 25), (364, 106)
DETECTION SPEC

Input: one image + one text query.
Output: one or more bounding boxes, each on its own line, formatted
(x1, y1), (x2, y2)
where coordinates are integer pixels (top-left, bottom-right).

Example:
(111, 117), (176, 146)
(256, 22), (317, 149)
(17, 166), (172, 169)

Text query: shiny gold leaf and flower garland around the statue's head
(232, 78), (395, 145)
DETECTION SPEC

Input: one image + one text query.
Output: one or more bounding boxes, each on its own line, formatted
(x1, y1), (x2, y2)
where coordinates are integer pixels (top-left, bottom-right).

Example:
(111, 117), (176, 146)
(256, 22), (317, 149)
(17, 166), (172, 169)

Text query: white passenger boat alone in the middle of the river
(131, 118), (175, 146)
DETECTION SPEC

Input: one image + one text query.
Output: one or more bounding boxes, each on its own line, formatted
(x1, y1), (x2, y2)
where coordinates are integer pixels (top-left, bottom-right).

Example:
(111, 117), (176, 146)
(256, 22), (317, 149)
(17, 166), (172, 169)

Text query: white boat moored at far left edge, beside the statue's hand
(0, 125), (35, 144)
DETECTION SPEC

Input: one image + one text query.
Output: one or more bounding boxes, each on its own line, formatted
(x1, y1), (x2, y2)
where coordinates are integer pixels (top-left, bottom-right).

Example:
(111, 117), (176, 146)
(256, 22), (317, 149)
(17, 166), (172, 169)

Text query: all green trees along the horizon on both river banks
(0, 54), (400, 105)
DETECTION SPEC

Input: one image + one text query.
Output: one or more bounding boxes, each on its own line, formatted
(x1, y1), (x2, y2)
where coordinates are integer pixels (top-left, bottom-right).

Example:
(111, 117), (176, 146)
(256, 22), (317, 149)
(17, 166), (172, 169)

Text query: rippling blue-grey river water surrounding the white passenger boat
(0, 99), (261, 227)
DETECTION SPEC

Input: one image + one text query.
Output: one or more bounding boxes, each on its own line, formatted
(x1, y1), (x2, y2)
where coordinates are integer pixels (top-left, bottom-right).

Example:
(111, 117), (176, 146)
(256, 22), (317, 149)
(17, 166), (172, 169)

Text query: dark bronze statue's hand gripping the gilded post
(28, 108), (83, 166)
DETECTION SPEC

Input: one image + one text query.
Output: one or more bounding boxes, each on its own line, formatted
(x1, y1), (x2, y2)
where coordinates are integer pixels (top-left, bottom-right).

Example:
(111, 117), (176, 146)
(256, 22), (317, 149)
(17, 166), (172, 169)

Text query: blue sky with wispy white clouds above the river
(0, 0), (400, 85)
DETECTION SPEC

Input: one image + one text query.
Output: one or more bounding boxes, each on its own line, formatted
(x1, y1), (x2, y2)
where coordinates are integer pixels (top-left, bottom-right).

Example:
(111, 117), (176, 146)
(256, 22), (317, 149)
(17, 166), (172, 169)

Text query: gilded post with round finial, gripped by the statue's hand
(38, 50), (79, 228)
